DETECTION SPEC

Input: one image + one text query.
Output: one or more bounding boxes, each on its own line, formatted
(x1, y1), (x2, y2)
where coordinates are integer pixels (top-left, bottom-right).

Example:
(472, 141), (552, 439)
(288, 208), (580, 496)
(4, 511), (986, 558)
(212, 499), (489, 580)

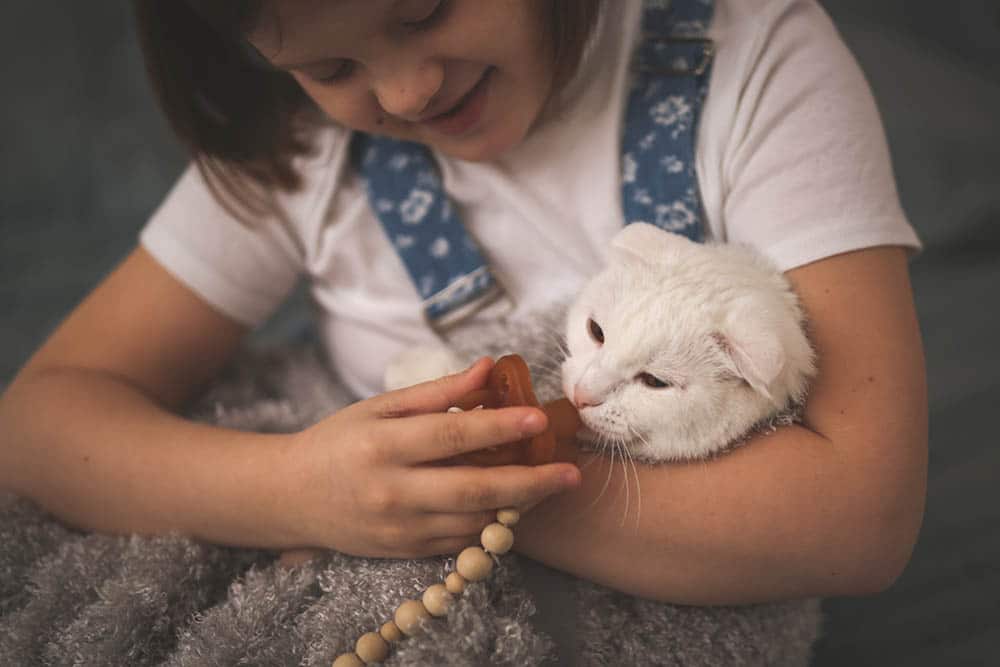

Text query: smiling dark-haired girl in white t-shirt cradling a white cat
(0, 0), (927, 604)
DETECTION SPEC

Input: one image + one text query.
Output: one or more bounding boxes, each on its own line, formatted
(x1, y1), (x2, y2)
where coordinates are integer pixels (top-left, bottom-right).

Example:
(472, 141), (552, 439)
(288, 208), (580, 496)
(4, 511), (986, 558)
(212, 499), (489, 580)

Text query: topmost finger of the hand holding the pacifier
(358, 357), (493, 418)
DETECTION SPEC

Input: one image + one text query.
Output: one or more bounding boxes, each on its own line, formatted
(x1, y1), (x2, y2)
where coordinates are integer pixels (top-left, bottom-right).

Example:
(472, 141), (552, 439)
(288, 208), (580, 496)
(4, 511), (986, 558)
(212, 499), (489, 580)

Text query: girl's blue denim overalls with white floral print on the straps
(351, 0), (714, 664)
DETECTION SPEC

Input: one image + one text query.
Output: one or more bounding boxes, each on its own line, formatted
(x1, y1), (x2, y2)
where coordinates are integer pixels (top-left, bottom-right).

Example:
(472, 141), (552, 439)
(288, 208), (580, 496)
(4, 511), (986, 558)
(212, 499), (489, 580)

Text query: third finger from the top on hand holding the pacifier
(408, 463), (580, 512)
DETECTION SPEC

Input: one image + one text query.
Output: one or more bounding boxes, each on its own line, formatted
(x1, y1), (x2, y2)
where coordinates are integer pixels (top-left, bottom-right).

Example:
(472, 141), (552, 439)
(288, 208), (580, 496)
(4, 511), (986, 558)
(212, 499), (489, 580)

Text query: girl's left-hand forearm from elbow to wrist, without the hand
(0, 369), (296, 547)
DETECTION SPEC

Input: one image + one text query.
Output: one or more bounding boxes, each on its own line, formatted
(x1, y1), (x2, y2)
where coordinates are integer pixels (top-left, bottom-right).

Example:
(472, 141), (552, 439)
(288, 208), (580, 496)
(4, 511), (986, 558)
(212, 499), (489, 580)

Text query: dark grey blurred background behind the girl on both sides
(0, 0), (1000, 667)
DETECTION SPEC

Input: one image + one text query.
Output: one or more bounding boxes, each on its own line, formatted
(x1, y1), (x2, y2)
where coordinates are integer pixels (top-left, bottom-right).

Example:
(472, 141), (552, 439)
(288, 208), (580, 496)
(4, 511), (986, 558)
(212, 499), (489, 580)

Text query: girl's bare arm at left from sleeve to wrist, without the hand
(0, 249), (292, 542)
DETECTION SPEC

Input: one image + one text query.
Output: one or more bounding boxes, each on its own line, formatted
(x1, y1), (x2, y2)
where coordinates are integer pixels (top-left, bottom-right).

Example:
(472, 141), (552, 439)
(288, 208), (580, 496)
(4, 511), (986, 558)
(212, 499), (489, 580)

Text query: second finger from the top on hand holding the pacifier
(372, 407), (548, 465)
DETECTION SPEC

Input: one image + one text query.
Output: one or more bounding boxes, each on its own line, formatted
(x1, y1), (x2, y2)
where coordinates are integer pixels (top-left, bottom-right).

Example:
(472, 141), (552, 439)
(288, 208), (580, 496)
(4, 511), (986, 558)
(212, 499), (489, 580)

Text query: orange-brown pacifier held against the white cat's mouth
(447, 354), (581, 466)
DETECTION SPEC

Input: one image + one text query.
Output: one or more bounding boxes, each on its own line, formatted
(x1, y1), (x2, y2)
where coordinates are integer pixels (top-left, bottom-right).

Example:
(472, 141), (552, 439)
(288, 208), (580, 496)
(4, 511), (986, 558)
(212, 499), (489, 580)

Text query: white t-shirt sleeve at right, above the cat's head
(722, 0), (920, 270)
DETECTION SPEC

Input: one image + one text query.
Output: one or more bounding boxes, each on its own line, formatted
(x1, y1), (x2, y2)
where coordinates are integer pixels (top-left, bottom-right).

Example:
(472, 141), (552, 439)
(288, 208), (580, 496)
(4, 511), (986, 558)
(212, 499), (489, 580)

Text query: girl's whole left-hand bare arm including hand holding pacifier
(0, 249), (572, 556)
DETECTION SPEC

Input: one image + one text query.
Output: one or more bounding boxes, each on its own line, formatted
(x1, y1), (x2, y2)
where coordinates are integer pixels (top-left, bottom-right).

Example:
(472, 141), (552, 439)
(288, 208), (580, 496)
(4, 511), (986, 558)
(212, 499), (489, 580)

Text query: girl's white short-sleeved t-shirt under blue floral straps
(141, 0), (920, 397)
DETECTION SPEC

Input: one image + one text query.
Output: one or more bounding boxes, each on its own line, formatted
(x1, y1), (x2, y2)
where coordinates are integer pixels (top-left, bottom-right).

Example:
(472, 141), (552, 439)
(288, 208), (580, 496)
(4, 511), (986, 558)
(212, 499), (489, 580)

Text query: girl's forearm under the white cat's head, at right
(515, 426), (923, 605)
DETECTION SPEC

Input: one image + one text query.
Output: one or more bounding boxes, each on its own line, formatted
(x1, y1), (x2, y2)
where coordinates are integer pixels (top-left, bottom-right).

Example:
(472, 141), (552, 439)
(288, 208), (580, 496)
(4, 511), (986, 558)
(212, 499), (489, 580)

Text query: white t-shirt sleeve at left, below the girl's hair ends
(139, 165), (303, 327)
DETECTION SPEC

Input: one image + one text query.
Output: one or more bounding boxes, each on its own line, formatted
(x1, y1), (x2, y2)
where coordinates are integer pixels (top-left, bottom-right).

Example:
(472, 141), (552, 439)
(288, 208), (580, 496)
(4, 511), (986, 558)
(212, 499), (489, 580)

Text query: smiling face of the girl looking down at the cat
(250, 0), (553, 160)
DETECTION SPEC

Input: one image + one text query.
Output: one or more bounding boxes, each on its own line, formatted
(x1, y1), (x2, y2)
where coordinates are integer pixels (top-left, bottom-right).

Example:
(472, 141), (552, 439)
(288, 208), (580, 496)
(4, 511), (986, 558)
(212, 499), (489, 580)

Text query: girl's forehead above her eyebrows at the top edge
(247, 0), (392, 62)
